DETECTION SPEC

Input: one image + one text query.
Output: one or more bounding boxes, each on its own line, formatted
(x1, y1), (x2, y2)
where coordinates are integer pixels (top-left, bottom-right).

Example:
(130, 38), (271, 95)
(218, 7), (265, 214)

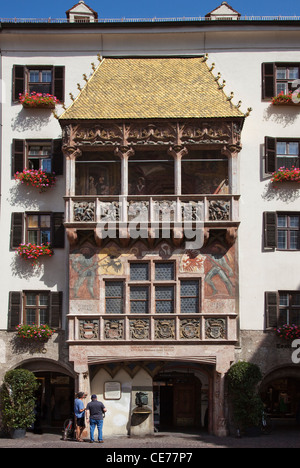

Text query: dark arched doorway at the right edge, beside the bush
(260, 367), (300, 427)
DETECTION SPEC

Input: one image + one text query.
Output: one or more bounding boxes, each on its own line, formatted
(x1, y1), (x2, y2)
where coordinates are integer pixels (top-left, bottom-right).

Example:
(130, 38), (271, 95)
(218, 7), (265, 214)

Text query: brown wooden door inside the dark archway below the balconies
(173, 383), (195, 427)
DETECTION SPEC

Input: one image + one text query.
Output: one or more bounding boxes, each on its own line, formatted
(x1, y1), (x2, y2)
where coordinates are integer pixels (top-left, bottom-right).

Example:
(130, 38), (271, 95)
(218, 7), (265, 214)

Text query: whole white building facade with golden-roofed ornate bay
(0, 2), (300, 436)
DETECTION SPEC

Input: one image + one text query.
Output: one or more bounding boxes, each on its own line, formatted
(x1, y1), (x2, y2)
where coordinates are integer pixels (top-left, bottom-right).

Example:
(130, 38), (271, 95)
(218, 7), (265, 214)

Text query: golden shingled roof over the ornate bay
(59, 57), (244, 120)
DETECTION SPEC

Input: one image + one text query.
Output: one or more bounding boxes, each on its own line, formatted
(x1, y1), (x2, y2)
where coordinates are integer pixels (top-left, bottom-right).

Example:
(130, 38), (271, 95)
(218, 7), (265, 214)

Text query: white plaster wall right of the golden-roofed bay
(205, 51), (300, 330)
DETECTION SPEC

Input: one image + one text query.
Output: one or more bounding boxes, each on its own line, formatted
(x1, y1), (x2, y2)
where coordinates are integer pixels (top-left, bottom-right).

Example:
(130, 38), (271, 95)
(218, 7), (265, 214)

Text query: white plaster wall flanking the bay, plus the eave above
(0, 23), (300, 330)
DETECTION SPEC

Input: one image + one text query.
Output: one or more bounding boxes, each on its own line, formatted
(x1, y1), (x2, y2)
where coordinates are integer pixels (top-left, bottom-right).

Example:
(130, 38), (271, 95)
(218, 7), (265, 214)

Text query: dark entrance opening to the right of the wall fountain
(153, 371), (204, 431)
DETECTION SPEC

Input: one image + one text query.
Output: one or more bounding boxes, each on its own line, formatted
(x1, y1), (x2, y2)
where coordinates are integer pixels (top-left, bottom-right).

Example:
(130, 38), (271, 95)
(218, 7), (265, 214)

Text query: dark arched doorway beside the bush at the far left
(18, 360), (75, 432)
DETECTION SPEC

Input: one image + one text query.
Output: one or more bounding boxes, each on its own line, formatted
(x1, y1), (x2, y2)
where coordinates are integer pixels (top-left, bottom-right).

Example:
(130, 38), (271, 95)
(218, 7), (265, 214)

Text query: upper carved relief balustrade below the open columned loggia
(65, 195), (239, 228)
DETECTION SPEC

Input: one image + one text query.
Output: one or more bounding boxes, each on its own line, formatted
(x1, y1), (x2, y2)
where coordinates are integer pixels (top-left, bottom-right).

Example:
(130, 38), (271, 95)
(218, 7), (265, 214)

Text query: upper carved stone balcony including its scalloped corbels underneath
(65, 194), (239, 245)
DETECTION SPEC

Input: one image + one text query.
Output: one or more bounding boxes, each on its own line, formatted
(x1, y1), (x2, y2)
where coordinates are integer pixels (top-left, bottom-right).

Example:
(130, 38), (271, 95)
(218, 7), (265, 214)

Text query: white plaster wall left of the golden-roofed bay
(0, 50), (97, 329)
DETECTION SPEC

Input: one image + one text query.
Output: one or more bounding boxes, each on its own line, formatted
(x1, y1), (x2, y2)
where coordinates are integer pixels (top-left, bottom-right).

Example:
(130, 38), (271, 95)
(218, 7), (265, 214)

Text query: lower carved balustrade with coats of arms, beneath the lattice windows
(69, 313), (237, 343)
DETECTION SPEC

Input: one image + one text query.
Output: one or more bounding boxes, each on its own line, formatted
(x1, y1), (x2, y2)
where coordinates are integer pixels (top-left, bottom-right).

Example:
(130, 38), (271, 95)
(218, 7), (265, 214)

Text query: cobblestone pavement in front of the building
(0, 427), (300, 450)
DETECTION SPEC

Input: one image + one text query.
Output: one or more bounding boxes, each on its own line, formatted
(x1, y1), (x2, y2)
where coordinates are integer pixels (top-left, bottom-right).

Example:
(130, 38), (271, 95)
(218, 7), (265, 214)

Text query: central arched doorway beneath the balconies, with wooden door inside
(153, 364), (209, 431)
